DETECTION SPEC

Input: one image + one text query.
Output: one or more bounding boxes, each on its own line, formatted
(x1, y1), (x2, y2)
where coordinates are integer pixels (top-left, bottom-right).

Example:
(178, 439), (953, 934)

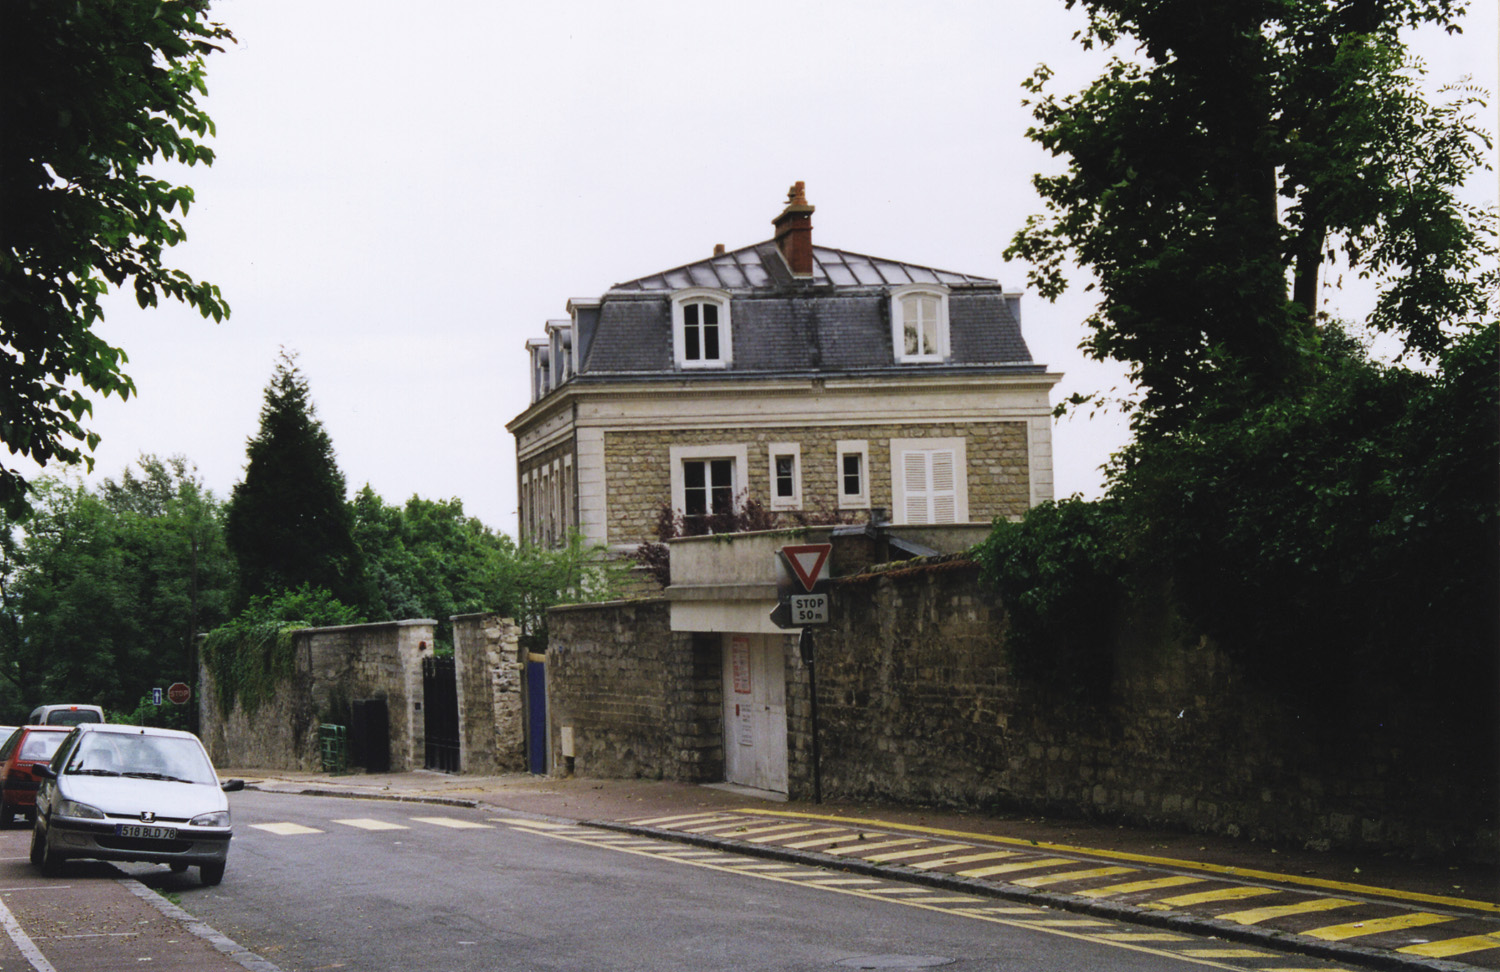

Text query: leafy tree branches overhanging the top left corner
(0, 0), (234, 518)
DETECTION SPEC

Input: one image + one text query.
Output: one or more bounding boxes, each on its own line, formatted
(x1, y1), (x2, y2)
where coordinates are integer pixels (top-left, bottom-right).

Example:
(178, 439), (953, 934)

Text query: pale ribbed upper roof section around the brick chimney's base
(609, 240), (999, 294)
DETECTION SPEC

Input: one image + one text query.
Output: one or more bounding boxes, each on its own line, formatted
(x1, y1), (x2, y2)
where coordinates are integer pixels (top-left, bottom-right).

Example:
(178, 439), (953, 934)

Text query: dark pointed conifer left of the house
(225, 351), (365, 606)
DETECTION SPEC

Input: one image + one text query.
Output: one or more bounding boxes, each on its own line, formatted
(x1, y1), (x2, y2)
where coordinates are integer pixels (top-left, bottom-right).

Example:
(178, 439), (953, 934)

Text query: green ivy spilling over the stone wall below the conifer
(203, 585), (365, 716)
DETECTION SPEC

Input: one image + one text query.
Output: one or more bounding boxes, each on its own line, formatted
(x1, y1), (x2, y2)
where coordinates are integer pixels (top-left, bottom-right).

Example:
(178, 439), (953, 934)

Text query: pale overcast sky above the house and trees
(20, 0), (1497, 534)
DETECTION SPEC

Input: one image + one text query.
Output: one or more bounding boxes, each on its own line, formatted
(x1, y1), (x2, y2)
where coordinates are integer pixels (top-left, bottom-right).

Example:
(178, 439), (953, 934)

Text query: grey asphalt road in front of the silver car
(105, 792), (1362, 972)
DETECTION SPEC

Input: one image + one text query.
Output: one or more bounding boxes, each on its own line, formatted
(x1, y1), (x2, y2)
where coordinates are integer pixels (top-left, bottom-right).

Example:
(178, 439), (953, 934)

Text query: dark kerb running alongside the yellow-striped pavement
(591, 821), (1479, 972)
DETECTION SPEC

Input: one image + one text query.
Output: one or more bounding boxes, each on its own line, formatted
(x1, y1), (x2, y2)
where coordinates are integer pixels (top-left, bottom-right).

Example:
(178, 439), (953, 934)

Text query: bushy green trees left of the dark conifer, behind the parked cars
(0, 456), (233, 716)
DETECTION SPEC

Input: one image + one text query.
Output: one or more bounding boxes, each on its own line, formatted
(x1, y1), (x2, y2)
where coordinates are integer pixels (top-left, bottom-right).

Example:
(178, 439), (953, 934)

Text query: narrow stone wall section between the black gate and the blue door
(453, 614), (527, 774)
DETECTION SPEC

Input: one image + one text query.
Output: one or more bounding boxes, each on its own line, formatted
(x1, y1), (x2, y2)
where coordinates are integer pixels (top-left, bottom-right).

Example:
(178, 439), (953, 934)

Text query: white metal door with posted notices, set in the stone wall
(725, 635), (786, 794)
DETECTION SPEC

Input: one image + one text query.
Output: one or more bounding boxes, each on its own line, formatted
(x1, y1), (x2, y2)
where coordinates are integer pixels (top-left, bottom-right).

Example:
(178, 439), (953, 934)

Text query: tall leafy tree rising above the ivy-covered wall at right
(1007, 0), (1496, 435)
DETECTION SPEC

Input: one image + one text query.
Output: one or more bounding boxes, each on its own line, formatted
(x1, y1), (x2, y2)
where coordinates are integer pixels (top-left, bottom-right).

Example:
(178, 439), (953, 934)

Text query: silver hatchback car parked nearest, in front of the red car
(32, 723), (245, 885)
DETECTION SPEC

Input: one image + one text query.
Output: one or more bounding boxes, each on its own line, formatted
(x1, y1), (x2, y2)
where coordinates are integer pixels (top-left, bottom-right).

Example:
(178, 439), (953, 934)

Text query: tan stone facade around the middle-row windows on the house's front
(605, 422), (1031, 545)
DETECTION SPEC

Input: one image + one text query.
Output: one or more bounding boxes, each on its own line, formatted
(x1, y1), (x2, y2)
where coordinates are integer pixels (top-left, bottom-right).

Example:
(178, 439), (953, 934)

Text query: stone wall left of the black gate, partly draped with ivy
(198, 620), (435, 771)
